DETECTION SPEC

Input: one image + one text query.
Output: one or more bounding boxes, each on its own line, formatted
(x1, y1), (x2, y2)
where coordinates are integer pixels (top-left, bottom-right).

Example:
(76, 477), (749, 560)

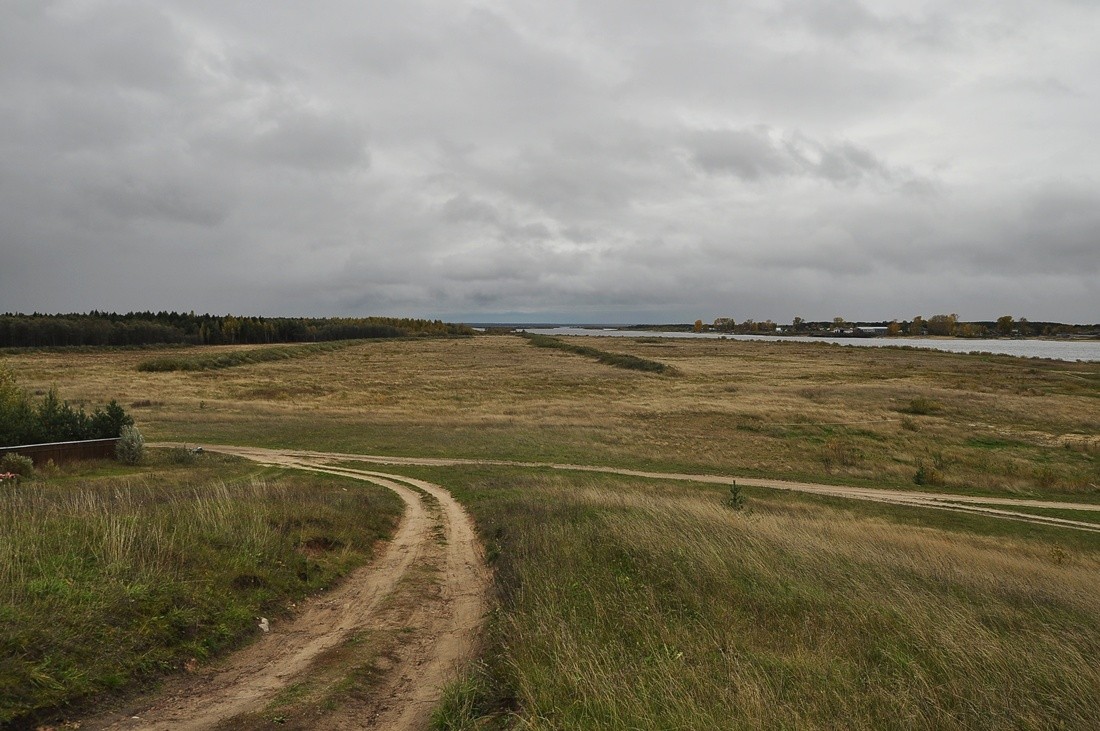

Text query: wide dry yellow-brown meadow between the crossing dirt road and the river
(2, 336), (1100, 499)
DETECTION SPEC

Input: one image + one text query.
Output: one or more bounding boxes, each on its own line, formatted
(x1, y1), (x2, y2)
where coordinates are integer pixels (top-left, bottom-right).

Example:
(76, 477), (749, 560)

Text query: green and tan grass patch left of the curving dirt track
(0, 455), (402, 728)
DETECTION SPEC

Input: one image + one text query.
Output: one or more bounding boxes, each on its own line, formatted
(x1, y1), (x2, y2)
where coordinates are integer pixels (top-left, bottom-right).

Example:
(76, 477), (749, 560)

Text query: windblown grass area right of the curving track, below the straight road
(422, 468), (1100, 730)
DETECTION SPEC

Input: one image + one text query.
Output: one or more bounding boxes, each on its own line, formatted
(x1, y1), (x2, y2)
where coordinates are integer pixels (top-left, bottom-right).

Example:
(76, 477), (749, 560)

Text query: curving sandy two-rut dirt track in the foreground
(81, 447), (490, 730)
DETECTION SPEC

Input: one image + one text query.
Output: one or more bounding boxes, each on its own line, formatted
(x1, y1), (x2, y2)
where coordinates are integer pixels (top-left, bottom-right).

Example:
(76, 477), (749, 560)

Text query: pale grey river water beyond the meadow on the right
(525, 328), (1100, 362)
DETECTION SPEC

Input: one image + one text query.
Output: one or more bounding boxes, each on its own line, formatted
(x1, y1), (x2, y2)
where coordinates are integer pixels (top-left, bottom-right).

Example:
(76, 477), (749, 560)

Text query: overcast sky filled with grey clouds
(0, 0), (1100, 322)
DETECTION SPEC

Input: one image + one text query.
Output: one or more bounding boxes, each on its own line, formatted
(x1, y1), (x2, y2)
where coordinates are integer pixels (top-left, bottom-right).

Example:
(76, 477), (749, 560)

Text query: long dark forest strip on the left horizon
(0, 311), (473, 347)
